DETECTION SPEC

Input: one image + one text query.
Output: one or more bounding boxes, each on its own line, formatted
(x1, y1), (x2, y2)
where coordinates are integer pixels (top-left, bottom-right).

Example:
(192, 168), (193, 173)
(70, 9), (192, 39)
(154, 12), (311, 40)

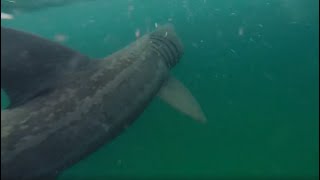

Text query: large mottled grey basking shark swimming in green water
(1, 24), (206, 180)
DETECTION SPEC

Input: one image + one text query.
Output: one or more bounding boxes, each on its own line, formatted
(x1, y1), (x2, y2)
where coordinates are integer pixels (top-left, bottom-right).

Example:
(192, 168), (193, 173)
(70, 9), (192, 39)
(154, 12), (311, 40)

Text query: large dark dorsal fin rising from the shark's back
(1, 27), (89, 108)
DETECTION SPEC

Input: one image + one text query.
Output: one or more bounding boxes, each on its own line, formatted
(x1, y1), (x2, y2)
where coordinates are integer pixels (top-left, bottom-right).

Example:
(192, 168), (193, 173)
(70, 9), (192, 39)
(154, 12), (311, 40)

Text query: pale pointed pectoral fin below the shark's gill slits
(158, 77), (207, 123)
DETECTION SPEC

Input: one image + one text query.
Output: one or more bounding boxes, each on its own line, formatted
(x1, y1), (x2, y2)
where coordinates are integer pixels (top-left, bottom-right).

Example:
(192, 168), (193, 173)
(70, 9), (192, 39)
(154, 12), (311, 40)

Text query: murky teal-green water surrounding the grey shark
(1, 0), (319, 180)
